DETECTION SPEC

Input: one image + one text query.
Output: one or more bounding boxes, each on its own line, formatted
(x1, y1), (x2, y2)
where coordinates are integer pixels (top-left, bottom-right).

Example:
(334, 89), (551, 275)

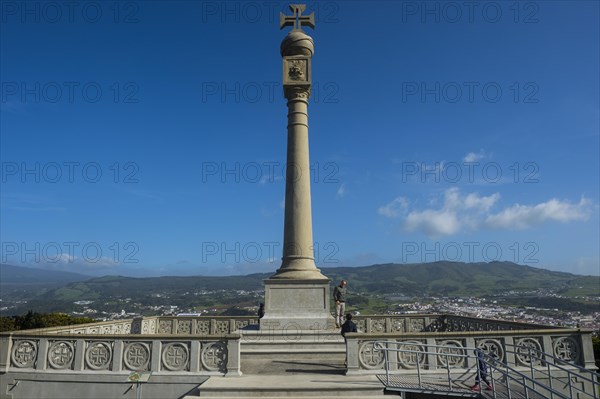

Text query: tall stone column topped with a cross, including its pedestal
(261, 4), (335, 330)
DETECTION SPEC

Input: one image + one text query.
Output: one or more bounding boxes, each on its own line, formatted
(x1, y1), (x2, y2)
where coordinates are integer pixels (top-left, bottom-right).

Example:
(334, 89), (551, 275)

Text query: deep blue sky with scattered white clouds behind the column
(0, 1), (600, 275)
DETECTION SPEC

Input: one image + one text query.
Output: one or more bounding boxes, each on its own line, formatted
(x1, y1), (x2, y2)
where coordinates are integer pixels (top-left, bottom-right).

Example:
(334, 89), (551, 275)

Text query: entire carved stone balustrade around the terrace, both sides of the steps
(0, 314), (594, 375)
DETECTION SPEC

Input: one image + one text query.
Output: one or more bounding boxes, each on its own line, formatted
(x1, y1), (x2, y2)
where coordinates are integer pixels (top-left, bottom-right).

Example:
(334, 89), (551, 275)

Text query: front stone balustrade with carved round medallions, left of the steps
(0, 331), (240, 375)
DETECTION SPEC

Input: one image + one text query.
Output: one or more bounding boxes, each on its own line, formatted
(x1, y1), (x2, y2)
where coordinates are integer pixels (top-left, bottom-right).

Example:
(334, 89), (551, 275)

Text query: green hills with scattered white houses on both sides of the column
(2, 262), (600, 314)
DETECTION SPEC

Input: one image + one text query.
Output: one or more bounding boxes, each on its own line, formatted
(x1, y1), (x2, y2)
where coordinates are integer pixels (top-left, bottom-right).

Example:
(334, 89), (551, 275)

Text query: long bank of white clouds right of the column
(378, 187), (590, 238)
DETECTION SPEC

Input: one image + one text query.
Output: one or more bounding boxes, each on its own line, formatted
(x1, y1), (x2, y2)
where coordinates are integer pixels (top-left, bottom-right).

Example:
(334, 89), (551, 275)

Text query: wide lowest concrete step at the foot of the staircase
(193, 373), (384, 399)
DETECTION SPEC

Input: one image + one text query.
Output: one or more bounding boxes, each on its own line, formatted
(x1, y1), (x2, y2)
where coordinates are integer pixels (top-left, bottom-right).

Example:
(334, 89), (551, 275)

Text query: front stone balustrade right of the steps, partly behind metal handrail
(346, 328), (595, 374)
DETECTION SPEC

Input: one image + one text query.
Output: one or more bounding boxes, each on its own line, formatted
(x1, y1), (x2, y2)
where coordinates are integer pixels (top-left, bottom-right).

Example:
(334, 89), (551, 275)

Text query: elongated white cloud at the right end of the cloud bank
(485, 198), (590, 230)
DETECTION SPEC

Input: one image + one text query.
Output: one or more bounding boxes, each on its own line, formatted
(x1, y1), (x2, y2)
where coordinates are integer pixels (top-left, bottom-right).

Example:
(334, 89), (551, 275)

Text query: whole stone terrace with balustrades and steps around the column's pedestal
(0, 314), (595, 399)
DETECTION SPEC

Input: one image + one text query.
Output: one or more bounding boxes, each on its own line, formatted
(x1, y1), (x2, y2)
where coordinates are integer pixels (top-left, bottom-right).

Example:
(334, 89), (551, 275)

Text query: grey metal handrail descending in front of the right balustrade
(373, 340), (597, 399)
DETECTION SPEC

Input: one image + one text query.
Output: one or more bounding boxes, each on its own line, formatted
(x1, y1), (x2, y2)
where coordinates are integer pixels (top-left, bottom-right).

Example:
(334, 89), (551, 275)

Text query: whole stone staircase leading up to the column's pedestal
(184, 329), (384, 399)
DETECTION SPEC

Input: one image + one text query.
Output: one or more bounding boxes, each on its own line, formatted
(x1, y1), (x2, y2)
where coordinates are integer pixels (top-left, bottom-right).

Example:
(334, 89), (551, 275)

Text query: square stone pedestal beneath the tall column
(260, 279), (335, 330)
